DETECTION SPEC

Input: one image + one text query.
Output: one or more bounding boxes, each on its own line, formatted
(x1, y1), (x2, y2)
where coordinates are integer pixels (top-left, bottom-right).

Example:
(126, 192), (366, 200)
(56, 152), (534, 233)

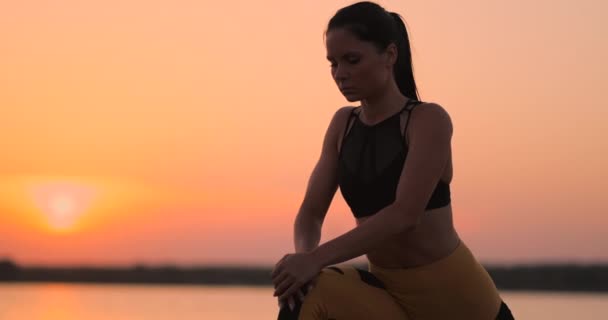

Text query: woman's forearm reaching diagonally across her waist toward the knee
(312, 206), (415, 268)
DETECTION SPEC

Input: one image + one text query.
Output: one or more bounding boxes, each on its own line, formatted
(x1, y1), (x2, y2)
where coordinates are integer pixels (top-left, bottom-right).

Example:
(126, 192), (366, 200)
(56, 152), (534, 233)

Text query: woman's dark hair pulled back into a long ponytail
(325, 1), (420, 100)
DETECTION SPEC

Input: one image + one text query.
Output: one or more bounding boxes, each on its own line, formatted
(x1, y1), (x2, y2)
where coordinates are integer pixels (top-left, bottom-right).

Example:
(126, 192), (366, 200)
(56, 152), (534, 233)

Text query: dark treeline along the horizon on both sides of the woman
(0, 260), (608, 292)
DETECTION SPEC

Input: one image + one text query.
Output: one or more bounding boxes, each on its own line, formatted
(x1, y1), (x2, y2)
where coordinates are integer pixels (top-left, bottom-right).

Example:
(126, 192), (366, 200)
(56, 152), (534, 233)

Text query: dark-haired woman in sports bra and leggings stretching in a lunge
(272, 2), (513, 320)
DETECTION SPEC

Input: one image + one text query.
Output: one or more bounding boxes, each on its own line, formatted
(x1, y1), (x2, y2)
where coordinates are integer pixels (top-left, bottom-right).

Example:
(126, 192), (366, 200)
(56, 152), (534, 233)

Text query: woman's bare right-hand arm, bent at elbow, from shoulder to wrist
(311, 104), (453, 268)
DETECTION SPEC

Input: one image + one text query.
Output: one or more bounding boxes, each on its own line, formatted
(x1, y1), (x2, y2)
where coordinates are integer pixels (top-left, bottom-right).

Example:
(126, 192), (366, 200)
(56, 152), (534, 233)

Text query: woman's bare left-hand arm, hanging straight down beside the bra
(294, 107), (351, 253)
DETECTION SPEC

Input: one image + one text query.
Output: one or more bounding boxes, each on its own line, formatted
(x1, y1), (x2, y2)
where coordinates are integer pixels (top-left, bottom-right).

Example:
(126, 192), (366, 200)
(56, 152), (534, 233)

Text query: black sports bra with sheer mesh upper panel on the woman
(338, 100), (450, 218)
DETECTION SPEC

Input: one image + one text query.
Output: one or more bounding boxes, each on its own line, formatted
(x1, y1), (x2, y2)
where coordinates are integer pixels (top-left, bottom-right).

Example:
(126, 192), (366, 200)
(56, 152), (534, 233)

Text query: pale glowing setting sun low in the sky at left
(32, 182), (94, 231)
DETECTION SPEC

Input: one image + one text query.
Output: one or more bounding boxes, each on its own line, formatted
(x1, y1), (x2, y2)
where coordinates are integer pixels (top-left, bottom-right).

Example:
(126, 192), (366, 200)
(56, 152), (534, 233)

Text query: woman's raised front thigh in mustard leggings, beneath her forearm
(279, 266), (409, 320)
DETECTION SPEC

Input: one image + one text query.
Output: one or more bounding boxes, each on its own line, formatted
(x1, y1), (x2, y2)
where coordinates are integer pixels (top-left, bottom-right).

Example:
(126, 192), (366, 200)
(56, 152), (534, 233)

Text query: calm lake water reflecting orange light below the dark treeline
(0, 283), (608, 320)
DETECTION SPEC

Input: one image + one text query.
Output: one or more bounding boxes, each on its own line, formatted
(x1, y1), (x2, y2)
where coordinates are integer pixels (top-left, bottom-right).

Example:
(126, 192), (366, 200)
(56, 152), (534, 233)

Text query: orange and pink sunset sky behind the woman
(0, 0), (608, 265)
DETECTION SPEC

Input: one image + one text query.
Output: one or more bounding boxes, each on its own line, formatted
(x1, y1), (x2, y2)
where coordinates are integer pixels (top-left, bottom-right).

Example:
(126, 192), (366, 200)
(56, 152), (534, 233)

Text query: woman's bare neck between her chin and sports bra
(361, 84), (410, 124)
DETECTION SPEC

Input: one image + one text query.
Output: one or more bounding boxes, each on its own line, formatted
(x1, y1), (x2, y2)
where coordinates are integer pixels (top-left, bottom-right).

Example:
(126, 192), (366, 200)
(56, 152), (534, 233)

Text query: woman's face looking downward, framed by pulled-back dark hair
(325, 28), (396, 102)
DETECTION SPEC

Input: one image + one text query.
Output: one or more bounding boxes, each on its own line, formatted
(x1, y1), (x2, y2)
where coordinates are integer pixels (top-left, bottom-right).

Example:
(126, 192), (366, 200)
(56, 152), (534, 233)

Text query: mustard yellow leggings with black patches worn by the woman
(278, 242), (513, 320)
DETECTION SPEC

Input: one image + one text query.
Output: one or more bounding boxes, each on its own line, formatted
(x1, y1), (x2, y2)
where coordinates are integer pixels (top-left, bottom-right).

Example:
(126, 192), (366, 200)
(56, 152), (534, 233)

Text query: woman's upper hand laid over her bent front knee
(272, 252), (322, 301)
